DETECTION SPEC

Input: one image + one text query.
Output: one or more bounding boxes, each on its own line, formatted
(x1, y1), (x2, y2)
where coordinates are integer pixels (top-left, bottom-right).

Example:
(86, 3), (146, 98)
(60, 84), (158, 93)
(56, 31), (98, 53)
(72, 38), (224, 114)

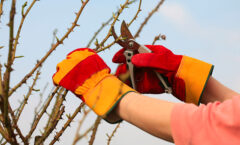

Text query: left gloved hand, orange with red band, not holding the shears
(53, 48), (134, 123)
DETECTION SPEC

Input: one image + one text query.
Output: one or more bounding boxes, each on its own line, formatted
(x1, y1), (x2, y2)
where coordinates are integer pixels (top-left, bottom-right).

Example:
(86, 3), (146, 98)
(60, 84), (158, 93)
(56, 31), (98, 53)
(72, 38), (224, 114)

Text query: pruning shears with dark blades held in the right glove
(112, 21), (172, 93)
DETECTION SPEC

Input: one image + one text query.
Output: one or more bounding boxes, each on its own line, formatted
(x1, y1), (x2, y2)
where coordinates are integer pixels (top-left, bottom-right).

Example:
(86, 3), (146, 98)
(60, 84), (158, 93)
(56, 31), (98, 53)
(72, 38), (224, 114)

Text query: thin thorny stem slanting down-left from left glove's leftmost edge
(26, 87), (59, 141)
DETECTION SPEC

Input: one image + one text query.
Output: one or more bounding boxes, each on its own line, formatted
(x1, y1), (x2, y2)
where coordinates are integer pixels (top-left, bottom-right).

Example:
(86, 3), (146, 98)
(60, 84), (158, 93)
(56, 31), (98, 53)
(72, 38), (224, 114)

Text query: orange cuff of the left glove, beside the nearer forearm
(83, 75), (135, 118)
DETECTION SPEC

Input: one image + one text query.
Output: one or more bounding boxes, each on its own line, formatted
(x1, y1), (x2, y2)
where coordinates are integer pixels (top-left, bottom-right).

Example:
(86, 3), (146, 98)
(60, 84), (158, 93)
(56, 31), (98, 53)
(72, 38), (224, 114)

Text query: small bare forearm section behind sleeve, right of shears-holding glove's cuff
(201, 77), (240, 104)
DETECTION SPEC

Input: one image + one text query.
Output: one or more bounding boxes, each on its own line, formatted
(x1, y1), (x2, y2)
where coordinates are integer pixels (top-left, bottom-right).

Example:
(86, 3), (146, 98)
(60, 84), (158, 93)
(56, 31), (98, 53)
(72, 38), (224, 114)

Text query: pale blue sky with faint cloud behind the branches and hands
(0, 0), (240, 145)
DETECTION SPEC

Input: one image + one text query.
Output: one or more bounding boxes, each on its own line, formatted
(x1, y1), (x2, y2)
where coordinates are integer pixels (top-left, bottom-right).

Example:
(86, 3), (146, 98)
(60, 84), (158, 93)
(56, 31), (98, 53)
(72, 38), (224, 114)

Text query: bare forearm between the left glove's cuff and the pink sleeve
(116, 93), (174, 142)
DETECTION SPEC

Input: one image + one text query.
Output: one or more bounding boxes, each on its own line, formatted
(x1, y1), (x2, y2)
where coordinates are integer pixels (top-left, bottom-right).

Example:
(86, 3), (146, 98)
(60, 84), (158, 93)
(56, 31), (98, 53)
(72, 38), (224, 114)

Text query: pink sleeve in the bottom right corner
(171, 96), (240, 145)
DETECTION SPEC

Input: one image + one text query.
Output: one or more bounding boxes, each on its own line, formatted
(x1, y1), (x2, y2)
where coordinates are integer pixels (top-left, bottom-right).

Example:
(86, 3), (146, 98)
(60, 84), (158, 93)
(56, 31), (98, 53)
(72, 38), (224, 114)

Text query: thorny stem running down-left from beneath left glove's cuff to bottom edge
(49, 104), (83, 145)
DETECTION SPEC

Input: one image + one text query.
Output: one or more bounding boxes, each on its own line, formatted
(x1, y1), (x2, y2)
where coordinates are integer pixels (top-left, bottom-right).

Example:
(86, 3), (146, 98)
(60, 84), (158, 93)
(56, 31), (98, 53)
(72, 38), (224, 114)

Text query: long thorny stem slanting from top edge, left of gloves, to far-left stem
(9, 0), (89, 96)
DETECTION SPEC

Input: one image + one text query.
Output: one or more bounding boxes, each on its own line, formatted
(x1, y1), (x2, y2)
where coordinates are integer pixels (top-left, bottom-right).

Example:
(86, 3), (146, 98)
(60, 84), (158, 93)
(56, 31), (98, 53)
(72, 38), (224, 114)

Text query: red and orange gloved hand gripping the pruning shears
(113, 45), (213, 104)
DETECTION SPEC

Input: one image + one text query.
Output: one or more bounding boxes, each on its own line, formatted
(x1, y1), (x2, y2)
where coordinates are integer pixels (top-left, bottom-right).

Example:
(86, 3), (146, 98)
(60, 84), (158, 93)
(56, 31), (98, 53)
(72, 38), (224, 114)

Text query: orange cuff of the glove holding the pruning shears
(176, 56), (214, 105)
